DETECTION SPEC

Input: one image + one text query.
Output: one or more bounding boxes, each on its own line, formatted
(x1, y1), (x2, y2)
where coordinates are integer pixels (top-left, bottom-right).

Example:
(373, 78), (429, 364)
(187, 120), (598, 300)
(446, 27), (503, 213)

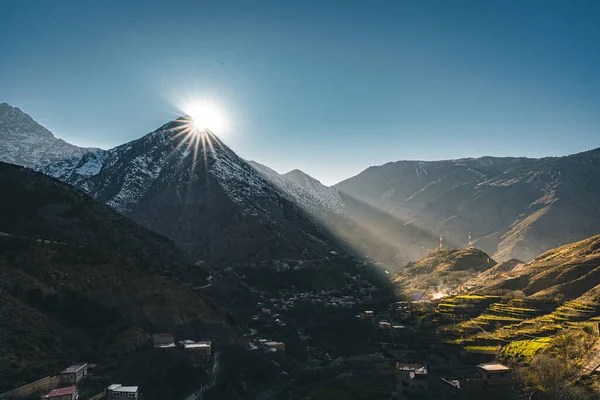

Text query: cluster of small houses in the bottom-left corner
(41, 363), (139, 400)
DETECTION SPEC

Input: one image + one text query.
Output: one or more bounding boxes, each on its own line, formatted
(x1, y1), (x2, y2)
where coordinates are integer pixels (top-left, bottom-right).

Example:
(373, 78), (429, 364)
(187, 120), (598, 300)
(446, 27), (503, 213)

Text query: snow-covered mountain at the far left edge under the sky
(0, 103), (102, 170)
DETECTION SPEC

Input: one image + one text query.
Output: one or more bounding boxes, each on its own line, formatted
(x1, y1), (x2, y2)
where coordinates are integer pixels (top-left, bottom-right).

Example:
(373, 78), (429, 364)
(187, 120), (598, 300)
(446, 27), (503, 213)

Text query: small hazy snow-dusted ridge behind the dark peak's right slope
(248, 161), (344, 214)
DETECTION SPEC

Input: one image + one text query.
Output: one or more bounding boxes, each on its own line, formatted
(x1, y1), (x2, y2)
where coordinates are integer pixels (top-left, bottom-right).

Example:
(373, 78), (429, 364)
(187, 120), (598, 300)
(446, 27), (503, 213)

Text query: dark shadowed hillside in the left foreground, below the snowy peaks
(0, 163), (234, 391)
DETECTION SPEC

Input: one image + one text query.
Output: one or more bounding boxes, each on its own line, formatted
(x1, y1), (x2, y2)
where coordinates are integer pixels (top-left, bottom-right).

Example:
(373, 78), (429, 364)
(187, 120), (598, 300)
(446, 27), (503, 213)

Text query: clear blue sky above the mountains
(0, 0), (600, 184)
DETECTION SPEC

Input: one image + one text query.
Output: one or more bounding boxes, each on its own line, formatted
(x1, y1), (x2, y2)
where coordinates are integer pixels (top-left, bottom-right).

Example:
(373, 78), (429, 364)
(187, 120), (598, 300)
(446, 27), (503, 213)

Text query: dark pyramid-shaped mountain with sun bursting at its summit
(54, 117), (346, 263)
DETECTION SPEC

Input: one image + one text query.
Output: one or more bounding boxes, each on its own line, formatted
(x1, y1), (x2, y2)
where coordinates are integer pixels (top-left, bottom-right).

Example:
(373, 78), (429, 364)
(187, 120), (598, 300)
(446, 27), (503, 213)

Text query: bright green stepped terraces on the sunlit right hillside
(436, 295), (600, 362)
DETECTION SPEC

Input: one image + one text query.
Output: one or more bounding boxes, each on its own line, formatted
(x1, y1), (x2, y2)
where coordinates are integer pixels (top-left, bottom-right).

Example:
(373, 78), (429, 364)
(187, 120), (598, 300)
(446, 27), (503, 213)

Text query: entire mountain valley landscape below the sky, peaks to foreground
(0, 104), (600, 400)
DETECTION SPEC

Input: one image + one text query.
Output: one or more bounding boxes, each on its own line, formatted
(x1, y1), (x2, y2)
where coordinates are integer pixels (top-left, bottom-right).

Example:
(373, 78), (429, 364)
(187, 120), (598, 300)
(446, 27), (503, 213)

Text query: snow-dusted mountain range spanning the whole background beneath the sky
(0, 104), (600, 268)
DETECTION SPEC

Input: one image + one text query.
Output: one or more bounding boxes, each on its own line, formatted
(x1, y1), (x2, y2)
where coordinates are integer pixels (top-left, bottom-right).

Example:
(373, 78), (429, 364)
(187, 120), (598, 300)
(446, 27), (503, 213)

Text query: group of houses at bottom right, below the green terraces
(396, 362), (513, 400)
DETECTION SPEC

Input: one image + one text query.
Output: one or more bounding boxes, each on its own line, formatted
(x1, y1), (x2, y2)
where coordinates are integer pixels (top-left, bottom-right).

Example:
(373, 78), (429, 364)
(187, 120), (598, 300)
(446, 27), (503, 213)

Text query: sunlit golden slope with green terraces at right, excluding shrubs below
(436, 236), (600, 361)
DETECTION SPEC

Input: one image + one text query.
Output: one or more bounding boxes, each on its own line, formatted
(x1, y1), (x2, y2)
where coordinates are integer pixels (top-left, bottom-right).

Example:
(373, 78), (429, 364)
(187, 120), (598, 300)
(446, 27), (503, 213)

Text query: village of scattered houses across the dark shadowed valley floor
(0, 253), (524, 400)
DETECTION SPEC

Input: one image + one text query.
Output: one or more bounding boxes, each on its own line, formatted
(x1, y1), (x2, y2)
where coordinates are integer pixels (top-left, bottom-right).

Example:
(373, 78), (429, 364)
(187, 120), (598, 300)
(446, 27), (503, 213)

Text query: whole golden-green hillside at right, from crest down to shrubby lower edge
(420, 235), (600, 398)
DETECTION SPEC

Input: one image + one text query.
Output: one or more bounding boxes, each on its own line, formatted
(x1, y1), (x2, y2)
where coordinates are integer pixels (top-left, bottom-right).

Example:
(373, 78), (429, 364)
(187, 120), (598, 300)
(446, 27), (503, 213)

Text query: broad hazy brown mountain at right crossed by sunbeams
(335, 149), (600, 261)
